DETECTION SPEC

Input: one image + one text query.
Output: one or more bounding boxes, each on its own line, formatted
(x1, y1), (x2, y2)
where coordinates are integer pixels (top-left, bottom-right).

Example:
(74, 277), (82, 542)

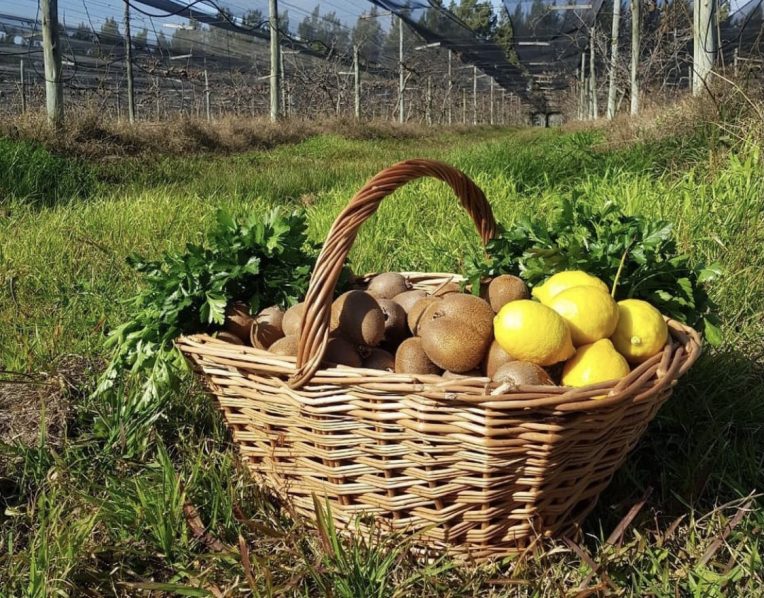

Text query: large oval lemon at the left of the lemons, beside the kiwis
(493, 299), (575, 365)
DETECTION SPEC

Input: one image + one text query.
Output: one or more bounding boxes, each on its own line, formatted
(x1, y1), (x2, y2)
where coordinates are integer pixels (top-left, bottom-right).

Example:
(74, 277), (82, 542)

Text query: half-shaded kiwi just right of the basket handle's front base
(329, 291), (385, 347)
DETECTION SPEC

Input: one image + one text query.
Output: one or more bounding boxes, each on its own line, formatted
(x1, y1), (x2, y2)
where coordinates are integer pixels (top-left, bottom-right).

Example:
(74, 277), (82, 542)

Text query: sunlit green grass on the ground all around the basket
(0, 118), (764, 597)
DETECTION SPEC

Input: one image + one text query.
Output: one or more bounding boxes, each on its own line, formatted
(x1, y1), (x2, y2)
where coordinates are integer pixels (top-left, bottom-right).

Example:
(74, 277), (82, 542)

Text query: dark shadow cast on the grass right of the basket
(584, 350), (764, 534)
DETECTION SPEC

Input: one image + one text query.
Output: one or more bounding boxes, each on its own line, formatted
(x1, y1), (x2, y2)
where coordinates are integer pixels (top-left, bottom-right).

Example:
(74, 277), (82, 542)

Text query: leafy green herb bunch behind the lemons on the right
(467, 197), (721, 345)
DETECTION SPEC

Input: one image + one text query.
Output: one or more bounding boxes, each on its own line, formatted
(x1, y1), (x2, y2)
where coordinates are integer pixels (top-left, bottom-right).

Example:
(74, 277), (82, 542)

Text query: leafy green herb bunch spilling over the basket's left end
(98, 210), (318, 402)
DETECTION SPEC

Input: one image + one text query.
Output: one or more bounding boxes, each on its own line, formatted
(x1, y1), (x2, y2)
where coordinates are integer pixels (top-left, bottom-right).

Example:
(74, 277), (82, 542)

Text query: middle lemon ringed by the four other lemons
(547, 287), (618, 347)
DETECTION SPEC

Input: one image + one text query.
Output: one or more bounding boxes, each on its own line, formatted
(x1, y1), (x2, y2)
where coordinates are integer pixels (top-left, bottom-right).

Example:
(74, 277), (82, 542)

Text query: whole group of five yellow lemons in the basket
(494, 270), (668, 386)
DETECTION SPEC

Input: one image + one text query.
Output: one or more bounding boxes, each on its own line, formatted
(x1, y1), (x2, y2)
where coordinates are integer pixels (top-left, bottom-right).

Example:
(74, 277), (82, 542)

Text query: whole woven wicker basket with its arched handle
(177, 160), (700, 560)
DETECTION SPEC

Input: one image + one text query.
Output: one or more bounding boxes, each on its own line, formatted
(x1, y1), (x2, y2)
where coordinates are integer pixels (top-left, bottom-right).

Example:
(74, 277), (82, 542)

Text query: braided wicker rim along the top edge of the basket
(176, 272), (702, 418)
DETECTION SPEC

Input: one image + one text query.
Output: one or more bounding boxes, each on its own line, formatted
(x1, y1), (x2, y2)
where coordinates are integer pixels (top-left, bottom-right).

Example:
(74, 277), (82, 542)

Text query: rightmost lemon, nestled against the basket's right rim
(610, 299), (668, 363)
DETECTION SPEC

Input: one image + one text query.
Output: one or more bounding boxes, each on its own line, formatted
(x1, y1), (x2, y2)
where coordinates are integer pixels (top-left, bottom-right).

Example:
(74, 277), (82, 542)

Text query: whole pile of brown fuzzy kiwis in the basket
(217, 272), (554, 387)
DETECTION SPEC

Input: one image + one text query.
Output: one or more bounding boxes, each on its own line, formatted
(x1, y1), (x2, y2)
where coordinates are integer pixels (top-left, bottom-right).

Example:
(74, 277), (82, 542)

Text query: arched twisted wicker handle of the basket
(289, 160), (496, 388)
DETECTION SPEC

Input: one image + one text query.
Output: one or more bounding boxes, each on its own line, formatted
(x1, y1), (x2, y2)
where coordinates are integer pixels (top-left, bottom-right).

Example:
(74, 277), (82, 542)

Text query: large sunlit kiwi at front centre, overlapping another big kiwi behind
(419, 316), (491, 374)
